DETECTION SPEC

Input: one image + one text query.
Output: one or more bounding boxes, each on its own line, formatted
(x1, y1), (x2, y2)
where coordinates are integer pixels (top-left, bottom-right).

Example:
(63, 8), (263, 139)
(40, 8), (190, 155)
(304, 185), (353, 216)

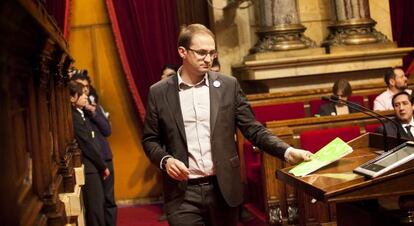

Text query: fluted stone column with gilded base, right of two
(324, 0), (390, 46)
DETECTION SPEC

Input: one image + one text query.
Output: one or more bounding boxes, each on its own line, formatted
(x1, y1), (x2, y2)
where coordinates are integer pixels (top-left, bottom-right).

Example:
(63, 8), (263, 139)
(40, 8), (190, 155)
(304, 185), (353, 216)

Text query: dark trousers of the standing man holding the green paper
(167, 183), (238, 226)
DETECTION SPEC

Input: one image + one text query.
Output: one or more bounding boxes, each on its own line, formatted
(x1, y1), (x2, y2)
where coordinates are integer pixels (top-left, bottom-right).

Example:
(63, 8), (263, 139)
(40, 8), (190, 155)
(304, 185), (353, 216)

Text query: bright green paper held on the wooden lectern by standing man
(289, 137), (353, 177)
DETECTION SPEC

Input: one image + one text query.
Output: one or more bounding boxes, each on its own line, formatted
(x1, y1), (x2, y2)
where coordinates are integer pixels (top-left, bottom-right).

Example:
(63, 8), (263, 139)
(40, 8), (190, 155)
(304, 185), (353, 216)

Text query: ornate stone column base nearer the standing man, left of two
(250, 0), (316, 53)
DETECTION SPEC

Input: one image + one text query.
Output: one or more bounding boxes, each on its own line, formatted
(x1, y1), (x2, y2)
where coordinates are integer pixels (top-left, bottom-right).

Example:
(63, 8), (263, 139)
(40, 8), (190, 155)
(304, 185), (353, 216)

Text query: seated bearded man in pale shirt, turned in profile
(374, 68), (411, 111)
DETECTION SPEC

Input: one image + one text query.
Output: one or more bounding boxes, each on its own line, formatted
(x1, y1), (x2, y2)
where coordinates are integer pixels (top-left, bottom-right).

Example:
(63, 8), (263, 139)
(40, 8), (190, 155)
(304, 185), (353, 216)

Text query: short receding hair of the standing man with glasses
(177, 24), (215, 49)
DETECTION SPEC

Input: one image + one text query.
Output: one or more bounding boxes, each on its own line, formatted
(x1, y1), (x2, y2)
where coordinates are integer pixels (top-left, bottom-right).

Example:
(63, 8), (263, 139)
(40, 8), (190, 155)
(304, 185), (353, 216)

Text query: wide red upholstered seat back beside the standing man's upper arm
(253, 102), (305, 124)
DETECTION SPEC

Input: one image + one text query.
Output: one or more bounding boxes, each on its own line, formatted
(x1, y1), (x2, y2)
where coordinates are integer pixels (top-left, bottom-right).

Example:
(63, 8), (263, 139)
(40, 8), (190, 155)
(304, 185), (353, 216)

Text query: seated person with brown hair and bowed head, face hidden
(319, 79), (358, 116)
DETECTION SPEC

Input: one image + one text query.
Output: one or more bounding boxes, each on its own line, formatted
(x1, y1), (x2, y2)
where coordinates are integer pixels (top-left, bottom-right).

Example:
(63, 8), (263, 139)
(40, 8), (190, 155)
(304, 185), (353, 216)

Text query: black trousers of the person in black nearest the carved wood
(82, 173), (105, 226)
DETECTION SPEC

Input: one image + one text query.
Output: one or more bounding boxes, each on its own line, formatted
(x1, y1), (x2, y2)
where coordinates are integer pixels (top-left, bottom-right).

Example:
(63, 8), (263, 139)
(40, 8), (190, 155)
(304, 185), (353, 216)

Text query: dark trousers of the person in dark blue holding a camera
(103, 160), (117, 226)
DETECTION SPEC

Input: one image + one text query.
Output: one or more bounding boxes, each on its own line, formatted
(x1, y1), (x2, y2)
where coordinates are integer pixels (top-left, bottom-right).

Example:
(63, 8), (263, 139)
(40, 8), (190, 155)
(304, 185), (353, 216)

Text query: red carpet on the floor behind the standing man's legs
(118, 205), (265, 226)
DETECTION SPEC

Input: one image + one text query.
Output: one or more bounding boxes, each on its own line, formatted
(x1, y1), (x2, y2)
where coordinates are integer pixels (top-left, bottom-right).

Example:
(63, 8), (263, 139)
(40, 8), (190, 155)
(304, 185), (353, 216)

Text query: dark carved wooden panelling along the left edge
(0, 0), (76, 226)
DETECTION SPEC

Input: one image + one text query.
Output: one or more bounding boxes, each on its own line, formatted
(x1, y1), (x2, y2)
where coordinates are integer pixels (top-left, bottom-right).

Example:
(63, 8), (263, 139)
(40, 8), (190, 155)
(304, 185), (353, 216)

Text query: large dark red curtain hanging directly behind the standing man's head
(106, 0), (179, 120)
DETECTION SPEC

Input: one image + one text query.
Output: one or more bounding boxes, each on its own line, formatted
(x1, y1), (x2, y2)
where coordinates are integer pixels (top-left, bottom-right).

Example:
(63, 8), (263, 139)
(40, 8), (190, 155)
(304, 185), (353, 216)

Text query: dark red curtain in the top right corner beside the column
(389, 0), (414, 70)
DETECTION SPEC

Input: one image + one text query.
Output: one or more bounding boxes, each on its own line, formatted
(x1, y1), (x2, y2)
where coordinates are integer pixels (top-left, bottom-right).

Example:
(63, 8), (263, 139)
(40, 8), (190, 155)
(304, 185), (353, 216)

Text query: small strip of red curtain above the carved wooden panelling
(45, 0), (70, 39)
